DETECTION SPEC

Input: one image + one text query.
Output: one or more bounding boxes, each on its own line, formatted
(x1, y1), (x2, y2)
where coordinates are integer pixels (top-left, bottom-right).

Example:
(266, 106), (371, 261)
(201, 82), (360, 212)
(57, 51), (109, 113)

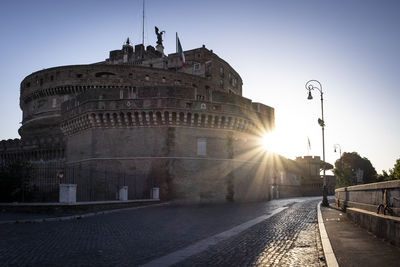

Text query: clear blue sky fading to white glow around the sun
(0, 0), (400, 175)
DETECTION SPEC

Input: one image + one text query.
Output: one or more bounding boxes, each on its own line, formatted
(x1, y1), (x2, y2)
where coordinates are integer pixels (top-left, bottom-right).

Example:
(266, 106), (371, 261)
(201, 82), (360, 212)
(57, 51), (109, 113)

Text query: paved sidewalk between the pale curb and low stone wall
(321, 203), (400, 267)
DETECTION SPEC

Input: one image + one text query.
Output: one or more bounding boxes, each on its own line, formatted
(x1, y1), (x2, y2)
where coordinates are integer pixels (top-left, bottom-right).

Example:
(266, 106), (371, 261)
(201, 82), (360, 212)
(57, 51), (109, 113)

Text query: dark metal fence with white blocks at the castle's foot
(15, 166), (154, 202)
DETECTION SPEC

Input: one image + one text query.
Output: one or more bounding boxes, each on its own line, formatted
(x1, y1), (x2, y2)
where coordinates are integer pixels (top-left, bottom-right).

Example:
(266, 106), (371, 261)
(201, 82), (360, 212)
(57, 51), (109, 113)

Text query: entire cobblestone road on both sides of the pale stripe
(0, 199), (322, 266)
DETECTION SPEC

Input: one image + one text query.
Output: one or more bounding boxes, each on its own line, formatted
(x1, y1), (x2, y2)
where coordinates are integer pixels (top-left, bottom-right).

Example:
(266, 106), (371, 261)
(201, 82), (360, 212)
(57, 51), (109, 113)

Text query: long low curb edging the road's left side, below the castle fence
(0, 202), (170, 225)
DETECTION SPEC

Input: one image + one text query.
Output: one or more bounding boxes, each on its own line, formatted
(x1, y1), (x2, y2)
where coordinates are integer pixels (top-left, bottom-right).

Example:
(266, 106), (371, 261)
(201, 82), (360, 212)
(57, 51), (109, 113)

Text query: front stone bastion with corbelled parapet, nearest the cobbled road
(61, 86), (274, 201)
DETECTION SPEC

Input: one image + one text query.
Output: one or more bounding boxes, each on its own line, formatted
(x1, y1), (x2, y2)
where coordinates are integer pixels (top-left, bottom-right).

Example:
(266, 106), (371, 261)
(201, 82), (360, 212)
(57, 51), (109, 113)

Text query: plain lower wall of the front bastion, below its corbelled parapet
(67, 126), (269, 201)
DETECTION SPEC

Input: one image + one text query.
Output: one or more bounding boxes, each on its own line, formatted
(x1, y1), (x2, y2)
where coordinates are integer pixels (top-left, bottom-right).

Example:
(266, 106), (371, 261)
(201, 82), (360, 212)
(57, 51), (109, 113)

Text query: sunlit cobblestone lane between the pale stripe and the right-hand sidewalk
(176, 201), (324, 266)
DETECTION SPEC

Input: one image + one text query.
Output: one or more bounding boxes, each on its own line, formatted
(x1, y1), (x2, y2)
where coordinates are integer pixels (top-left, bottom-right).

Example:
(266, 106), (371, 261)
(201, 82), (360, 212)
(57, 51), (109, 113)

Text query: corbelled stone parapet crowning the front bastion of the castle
(61, 87), (274, 135)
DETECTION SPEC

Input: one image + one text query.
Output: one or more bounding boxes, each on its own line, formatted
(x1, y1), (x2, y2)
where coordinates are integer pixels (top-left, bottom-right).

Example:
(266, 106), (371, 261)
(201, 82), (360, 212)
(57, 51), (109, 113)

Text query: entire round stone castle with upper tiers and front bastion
(0, 34), (332, 201)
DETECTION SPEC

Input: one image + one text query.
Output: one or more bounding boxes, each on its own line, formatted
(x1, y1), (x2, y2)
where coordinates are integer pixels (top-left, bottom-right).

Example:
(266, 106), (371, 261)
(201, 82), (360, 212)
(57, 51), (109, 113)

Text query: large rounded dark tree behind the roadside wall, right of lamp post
(333, 152), (378, 187)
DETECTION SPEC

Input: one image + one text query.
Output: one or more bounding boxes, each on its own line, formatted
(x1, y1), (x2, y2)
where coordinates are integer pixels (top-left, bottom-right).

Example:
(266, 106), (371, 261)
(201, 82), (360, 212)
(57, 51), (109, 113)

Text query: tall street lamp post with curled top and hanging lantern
(306, 80), (329, 207)
